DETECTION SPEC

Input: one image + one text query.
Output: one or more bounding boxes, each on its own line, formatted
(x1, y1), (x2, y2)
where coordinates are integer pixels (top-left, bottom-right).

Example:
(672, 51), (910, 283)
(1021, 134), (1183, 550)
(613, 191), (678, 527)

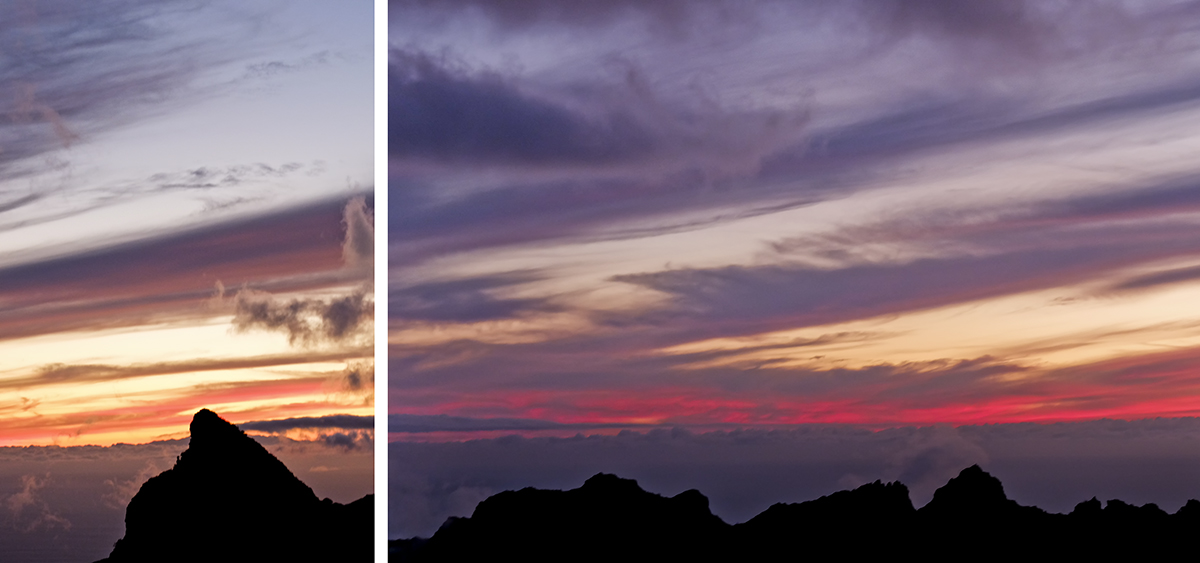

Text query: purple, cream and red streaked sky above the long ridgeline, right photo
(388, 0), (1200, 537)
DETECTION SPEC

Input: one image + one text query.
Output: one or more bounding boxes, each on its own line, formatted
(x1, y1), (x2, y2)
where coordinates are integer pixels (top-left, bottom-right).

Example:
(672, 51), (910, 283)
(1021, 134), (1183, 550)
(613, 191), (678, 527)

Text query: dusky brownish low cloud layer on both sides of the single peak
(0, 434), (373, 561)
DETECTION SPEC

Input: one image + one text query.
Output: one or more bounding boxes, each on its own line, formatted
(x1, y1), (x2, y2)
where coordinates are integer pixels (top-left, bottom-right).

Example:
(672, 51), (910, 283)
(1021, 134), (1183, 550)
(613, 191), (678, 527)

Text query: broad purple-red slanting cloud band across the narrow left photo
(0, 198), (361, 337)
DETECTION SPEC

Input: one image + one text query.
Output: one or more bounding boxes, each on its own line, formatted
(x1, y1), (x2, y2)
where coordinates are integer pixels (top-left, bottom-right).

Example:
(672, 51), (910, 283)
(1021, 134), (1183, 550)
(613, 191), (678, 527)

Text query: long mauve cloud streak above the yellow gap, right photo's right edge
(601, 176), (1200, 335)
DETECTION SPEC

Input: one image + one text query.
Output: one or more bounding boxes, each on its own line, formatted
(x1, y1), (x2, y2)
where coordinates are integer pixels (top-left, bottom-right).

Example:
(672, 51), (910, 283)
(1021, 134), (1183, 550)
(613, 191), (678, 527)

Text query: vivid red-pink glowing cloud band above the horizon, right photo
(394, 338), (1200, 441)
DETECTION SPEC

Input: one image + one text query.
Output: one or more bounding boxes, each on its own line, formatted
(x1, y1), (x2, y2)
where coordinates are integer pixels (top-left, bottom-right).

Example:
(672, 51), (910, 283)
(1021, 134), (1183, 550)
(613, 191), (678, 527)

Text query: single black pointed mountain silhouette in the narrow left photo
(97, 409), (374, 563)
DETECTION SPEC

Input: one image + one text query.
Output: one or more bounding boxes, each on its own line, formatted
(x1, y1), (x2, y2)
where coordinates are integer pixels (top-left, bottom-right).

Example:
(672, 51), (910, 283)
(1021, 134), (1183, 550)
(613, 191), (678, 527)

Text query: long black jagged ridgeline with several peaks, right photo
(389, 466), (1200, 563)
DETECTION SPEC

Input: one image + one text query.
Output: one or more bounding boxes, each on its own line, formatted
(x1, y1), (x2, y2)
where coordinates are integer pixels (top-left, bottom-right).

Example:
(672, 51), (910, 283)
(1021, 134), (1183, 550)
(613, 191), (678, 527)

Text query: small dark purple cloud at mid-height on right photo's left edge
(388, 271), (557, 322)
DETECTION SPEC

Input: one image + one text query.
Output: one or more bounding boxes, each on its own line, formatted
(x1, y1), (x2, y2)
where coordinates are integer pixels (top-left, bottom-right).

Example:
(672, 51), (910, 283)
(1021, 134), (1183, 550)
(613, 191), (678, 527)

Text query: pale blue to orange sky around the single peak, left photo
(0, 0), (374, 561)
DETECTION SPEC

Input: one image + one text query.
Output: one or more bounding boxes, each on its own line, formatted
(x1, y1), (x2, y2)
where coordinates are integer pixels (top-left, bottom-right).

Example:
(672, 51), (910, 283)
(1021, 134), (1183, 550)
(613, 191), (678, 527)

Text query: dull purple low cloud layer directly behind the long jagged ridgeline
(388, 418), (1200, 538)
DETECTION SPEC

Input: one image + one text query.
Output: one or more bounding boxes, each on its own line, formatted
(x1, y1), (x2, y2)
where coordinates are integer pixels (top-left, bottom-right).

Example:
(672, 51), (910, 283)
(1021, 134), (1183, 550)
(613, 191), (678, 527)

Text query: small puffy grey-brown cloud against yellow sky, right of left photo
(233, 289), (374, 346)
